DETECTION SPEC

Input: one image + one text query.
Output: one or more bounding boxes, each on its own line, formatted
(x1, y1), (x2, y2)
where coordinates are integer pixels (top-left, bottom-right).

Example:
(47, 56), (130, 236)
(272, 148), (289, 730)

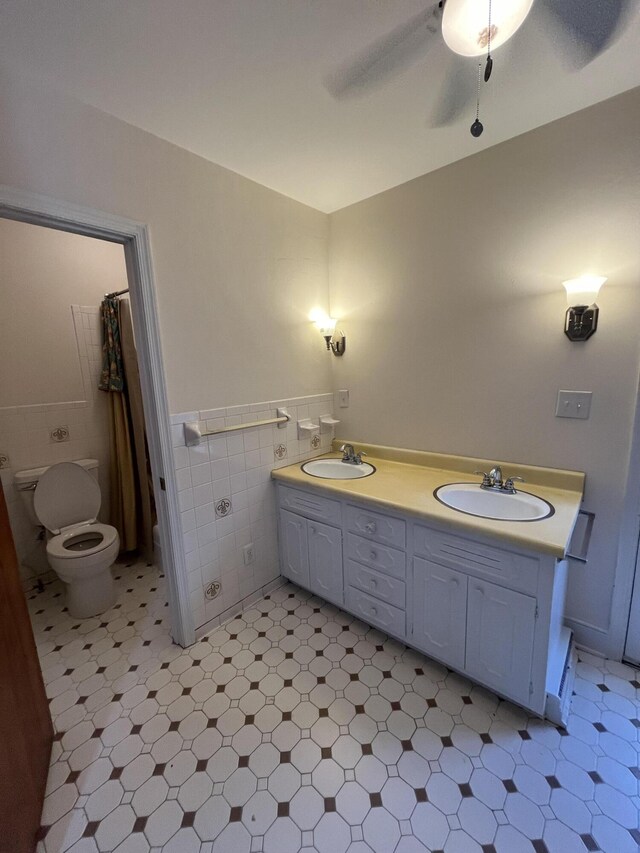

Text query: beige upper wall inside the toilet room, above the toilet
(0, 219), (127, 408)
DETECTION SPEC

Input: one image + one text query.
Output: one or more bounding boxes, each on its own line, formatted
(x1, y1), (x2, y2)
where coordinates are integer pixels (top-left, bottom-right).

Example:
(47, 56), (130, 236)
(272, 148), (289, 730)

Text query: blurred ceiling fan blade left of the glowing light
(324, 3), (442, 100)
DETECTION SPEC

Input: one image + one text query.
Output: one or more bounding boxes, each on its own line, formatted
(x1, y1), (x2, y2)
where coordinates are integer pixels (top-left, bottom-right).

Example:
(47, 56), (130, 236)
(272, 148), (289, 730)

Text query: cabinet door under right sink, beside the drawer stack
(412, 557), (467, 669)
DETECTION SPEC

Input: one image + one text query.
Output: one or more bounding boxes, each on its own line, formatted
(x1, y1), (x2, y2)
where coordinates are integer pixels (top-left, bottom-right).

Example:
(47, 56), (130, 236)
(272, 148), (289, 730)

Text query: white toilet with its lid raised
(15, 459), (120, 619)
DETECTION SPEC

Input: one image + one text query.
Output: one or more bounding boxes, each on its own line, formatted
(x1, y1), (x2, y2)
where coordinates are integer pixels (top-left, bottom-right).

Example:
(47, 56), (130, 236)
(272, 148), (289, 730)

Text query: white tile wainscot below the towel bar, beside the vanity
(171, 393), (334, 635)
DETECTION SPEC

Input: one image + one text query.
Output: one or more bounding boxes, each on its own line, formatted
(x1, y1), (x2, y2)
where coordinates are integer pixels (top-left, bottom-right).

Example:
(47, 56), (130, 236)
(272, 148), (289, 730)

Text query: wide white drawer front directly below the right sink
(413, 524), (538, 594)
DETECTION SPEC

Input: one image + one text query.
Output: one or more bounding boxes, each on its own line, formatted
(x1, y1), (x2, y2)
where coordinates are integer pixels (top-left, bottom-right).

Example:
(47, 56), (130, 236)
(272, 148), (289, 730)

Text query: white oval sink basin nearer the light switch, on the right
(433, 483), (555, 521)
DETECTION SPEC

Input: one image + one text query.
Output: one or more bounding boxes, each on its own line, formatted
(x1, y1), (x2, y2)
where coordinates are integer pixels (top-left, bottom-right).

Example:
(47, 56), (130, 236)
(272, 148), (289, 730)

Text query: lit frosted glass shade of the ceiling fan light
(442, 0), (533, 56)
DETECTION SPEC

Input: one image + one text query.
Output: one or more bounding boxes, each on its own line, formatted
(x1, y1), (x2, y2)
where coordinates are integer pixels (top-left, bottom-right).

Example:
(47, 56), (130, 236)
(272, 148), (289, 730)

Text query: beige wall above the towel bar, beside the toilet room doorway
(0, 69), (330, 412)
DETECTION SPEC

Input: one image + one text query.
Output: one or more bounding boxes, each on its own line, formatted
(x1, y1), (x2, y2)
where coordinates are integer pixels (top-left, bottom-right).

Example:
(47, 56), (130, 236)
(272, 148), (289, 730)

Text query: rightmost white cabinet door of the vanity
(465, 578), (536, 704)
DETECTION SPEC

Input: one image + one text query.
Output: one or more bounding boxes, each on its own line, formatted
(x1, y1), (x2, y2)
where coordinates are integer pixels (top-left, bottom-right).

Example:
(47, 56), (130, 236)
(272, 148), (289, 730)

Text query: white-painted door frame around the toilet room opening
(0, 184), (195, 646)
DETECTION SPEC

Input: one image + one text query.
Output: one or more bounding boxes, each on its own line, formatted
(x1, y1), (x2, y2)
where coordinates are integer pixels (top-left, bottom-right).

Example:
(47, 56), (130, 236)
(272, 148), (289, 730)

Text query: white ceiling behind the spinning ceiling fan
(0, 0), (640, 211)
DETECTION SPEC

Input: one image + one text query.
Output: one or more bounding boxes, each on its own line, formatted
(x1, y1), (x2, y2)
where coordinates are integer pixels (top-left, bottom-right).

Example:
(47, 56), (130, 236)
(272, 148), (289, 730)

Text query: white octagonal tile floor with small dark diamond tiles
(28, 565), (640, 853)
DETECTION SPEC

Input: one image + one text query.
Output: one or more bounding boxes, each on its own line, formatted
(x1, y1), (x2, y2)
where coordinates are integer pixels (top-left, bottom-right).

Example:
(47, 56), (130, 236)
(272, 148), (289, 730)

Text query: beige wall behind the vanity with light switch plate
(331, 90), (640, 649)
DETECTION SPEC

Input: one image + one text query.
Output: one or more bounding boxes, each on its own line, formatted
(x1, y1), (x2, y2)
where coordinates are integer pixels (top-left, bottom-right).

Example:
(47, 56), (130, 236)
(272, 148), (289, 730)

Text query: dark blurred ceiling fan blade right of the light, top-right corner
(541, 0), (635, 69)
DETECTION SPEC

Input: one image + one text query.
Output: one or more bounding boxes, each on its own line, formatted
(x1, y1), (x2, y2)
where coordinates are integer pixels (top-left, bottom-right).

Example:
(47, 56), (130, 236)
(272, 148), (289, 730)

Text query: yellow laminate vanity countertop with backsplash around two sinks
(272, 442), (584, 558)
